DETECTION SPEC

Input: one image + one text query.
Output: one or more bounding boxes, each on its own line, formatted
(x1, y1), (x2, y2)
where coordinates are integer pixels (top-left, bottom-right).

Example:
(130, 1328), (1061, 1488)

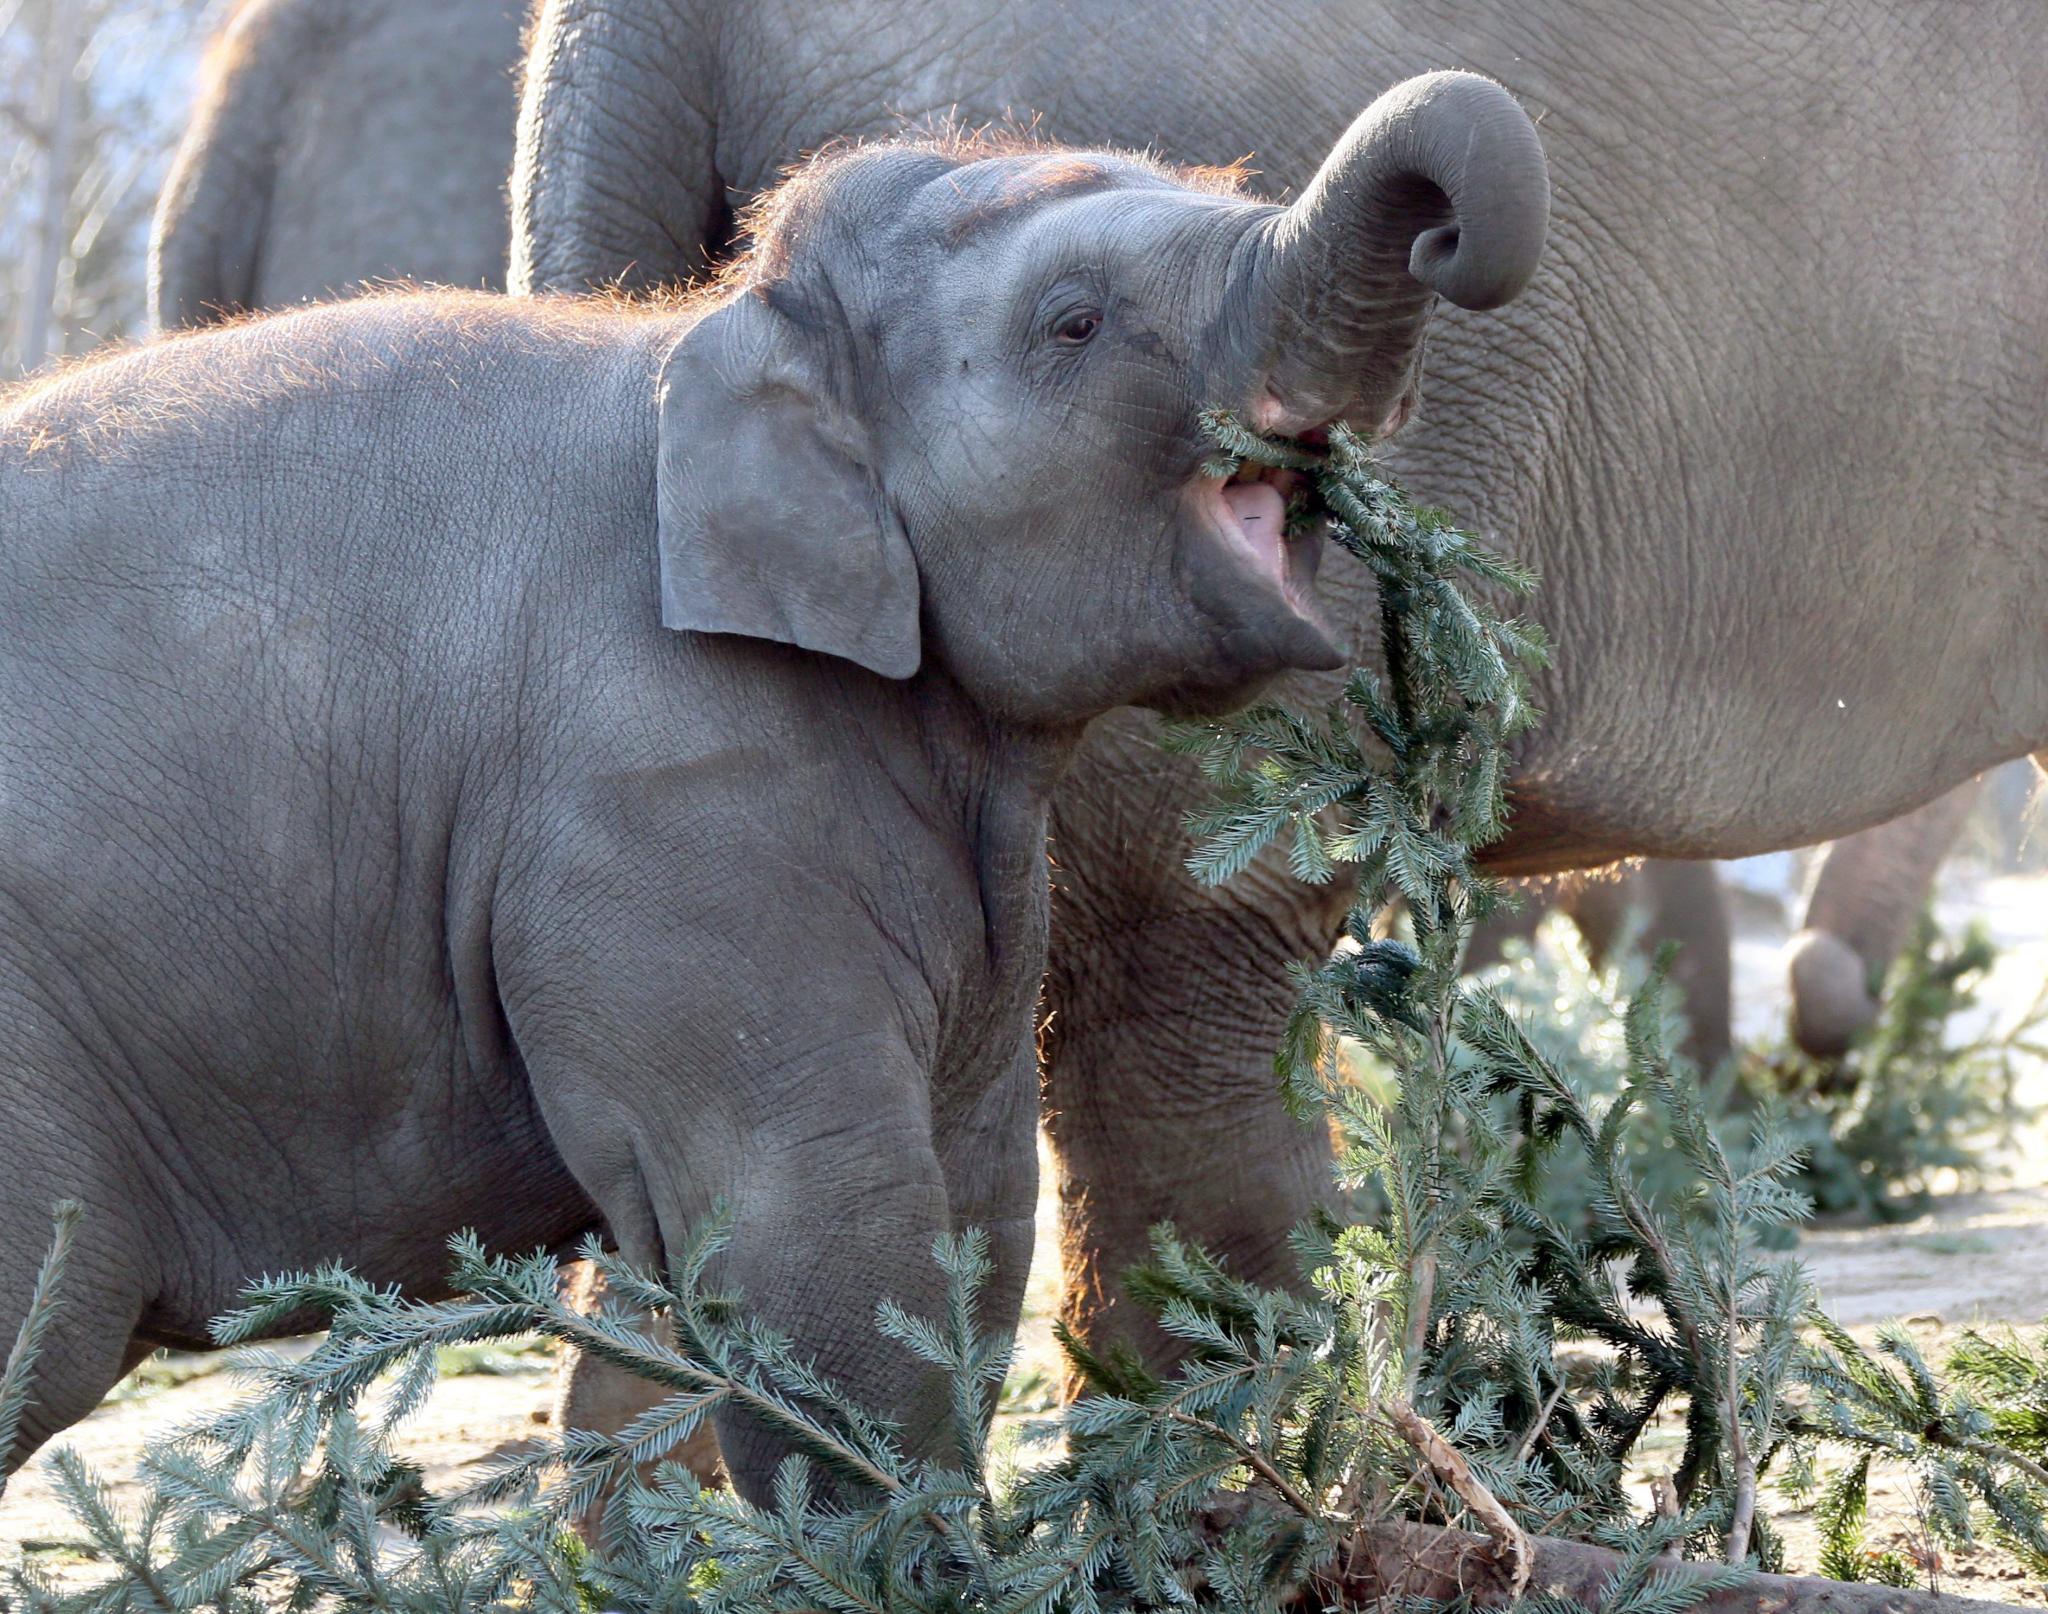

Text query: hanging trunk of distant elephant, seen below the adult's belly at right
(1786, 778), (1982, 1059)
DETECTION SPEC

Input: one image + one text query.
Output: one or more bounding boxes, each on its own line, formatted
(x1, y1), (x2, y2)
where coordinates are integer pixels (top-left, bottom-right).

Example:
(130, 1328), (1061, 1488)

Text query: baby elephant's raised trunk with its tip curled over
(1247, 72), (1550, 430)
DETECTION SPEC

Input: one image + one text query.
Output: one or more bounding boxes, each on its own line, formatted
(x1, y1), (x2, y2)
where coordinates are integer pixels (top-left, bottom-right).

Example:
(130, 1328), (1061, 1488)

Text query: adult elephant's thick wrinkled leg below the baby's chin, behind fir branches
(1042, 713), (1346, 1389)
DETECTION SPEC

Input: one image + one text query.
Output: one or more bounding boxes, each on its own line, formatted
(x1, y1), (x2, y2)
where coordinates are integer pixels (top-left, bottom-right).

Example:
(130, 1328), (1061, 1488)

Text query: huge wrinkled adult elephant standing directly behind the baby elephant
(514, 0), (2048, 1360)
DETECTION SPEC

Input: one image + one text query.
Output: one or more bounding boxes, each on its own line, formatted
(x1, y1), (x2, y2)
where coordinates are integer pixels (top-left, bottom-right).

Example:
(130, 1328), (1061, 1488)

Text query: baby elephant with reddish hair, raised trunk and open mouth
(0, 74), (1548, 1497)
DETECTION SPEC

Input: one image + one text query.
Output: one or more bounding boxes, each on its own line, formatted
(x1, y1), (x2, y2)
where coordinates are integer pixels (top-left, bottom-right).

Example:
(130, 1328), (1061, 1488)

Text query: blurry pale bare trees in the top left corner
(0, 0), (225, 375)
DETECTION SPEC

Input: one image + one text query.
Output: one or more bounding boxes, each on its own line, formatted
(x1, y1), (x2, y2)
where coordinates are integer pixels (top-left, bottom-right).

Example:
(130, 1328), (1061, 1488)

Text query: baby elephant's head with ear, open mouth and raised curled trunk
(659, 74), (1548, 723)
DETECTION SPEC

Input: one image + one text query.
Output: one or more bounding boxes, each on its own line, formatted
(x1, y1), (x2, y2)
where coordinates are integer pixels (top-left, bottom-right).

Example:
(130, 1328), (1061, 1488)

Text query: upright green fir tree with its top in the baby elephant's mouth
(1178, 418), (1806, 1567)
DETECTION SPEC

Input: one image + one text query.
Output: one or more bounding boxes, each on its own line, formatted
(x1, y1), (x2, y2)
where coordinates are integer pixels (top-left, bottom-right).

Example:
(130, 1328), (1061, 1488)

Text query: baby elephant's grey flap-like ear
(655, 295), (922, 678)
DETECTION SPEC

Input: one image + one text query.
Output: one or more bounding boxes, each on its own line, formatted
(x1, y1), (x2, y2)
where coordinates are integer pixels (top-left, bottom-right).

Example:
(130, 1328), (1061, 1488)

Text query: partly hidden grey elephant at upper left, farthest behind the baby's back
(150, 0), (526, 330)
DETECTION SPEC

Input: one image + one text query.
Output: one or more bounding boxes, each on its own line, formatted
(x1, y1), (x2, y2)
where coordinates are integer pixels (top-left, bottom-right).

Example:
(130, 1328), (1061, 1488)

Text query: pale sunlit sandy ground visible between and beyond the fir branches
(0, 843), (2048, 1604)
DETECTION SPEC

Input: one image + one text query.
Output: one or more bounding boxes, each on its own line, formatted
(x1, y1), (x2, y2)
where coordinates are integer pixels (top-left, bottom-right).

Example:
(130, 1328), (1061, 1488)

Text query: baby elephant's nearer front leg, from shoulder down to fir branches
(498, 846), (1028, 1501)
